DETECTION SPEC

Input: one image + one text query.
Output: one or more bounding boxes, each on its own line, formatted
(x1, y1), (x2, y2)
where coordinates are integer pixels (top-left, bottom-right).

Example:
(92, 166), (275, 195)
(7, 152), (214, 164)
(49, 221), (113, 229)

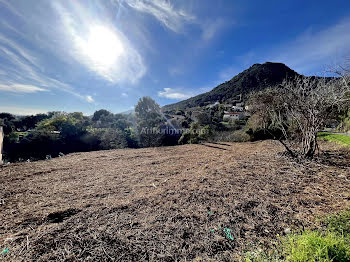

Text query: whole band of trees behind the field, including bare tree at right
(0, 62), (350, 161)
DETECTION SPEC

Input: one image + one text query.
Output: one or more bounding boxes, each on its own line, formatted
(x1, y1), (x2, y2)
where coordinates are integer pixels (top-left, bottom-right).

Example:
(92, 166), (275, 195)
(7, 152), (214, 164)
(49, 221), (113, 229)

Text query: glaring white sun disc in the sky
(83, 26), (124, 68)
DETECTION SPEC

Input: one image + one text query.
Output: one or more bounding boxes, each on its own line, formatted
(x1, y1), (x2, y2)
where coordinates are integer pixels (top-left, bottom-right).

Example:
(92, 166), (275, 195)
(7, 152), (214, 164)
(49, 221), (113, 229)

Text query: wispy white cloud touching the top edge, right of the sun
(125, 0), (195, 33)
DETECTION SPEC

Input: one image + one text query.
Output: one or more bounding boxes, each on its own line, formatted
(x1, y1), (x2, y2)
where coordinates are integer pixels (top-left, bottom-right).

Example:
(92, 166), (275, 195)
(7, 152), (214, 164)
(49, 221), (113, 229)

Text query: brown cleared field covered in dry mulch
(0, 141), (350, 261)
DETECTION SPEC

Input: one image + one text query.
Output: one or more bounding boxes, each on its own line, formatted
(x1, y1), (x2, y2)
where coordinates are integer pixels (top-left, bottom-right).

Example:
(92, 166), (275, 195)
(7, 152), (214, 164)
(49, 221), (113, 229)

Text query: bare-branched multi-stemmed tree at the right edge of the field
(248, 70), (350, 158)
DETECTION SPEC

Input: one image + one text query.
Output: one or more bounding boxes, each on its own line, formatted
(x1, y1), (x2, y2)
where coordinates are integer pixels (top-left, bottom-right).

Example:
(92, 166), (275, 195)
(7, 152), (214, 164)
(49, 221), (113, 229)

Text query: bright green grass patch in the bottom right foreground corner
(246, 209), (350, 262)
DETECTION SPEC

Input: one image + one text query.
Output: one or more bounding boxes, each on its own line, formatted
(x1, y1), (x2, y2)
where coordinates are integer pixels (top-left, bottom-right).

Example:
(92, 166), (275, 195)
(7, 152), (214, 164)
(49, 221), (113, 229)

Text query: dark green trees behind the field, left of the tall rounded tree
(0, 110), (138, 162)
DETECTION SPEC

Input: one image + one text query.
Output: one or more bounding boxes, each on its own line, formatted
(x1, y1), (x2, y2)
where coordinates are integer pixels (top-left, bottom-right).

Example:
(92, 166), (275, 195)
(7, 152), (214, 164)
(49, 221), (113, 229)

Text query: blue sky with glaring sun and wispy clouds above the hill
(0, 0), (350, 114)
